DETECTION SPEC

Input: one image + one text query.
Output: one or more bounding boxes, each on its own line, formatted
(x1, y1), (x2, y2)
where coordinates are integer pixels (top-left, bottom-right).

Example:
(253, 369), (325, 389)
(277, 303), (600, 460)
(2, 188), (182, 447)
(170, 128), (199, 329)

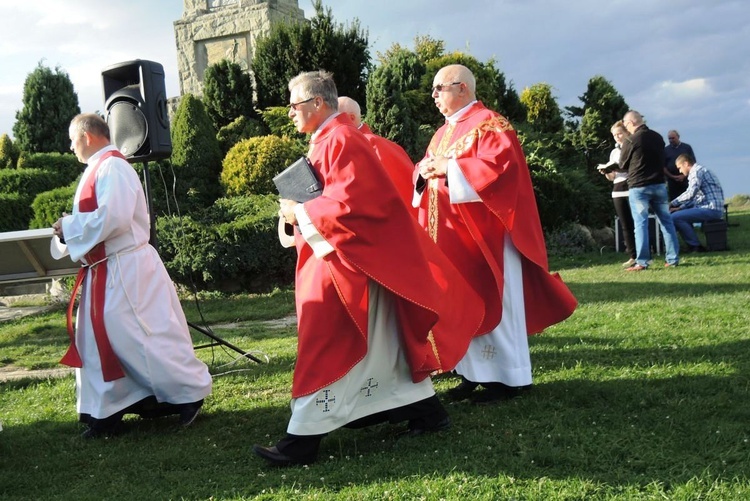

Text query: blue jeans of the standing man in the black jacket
(629, 183), (680, 266)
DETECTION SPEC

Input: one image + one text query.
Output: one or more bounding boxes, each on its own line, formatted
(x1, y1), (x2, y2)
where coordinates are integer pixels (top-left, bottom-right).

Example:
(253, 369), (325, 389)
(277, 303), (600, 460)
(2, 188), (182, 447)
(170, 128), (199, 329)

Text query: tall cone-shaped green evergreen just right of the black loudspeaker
(170, 94), (221, 211)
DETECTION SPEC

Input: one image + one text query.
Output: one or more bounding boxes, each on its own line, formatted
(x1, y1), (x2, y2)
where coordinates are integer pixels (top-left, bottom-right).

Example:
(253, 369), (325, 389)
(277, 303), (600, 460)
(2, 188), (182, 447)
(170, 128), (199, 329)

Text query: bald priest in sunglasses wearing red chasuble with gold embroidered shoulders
(413, 65), (577, 403)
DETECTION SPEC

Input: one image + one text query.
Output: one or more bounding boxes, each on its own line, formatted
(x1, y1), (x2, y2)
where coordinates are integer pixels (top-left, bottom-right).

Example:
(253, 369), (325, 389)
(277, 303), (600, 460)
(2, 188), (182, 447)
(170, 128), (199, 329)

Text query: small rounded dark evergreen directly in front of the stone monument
(203, 59), (257, 130)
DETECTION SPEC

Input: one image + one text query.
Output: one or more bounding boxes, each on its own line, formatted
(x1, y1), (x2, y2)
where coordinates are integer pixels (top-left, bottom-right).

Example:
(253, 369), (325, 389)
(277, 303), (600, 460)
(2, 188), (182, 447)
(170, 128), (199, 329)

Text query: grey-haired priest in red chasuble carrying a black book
(253, 71), (484, 466)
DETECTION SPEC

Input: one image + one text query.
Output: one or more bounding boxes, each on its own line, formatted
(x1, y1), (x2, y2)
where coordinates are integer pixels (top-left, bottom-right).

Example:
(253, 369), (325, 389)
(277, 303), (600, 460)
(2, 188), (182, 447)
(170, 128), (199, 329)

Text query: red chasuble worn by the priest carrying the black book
(292, 114), (484, 398)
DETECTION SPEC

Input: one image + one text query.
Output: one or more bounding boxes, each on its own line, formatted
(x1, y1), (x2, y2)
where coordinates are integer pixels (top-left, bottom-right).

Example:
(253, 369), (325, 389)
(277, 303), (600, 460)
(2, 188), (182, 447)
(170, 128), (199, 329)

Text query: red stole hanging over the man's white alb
(60, 150), (126, 381)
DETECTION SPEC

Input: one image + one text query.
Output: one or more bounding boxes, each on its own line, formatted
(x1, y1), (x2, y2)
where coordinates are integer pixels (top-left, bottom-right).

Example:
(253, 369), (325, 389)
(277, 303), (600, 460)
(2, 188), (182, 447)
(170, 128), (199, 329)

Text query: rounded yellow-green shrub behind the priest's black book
(221, 136), (305, 196)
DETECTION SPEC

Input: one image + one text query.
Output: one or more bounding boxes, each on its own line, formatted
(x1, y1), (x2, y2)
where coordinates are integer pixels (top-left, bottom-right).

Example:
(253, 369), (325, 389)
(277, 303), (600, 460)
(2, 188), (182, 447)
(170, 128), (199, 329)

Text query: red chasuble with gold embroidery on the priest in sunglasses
(416, 102), (577, 334)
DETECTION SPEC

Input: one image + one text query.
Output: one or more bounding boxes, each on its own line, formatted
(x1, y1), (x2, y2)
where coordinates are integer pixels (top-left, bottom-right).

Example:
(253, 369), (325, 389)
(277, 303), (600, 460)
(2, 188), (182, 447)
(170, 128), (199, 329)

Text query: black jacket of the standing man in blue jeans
(620, 125), (664, 188)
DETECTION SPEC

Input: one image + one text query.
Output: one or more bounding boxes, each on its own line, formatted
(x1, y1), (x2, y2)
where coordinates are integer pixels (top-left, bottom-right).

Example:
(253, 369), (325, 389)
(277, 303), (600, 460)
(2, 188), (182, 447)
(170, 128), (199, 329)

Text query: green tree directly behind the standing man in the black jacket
(565, 75), (628, 167)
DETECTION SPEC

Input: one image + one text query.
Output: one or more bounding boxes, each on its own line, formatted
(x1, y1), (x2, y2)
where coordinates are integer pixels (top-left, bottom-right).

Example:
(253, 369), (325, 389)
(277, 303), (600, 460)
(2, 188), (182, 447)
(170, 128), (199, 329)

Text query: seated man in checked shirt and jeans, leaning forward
(669, 153), (724, 252)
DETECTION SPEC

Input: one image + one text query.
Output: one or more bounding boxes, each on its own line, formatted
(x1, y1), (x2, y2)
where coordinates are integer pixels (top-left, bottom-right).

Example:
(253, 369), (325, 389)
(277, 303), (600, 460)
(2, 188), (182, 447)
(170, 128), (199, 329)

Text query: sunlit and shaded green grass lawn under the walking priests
(0, 212), (750, 500)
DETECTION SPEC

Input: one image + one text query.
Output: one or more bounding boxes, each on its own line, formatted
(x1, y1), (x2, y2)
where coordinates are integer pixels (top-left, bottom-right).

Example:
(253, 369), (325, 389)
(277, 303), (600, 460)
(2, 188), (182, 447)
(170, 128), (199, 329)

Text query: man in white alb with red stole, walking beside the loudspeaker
(52, 114), (211, 437)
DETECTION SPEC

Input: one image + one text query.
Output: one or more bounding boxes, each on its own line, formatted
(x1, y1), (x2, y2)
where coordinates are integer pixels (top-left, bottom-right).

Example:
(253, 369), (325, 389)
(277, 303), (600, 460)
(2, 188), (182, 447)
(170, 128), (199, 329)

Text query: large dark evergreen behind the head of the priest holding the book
(252, 0), (370, 109)
